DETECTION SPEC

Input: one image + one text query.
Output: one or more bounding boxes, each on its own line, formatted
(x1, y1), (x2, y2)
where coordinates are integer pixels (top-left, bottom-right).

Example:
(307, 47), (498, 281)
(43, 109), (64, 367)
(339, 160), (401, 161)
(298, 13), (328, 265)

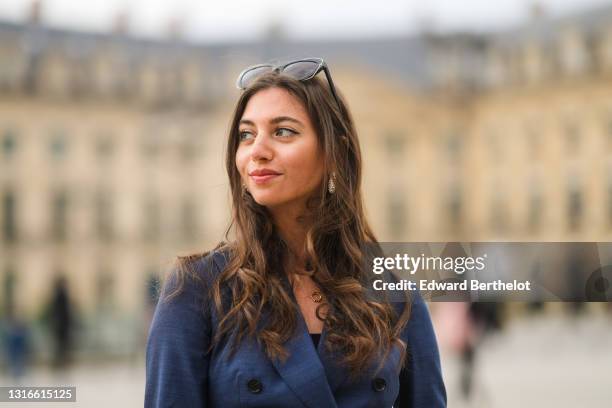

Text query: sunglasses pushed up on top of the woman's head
(236, 58), (340, 105)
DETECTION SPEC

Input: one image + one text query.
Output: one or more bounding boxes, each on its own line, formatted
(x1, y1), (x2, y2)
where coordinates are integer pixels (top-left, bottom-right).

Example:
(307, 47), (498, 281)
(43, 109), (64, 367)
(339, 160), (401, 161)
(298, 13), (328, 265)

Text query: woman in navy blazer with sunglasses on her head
(145, 58), (446, 408)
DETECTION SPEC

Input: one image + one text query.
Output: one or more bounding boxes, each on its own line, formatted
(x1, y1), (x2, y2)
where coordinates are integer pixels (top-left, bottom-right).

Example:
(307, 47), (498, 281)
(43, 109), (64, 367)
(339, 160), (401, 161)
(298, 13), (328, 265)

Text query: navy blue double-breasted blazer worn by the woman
(145, 251), (446, 408)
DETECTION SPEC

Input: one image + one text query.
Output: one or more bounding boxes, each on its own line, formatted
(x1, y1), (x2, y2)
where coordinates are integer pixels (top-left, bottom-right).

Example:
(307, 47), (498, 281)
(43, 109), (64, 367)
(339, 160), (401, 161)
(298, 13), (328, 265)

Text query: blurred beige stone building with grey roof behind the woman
(0, 2), (612, 350)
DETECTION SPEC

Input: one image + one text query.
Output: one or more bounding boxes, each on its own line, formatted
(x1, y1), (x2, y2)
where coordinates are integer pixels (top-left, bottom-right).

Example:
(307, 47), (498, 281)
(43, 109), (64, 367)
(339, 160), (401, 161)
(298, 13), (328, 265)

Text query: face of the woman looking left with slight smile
(236, 88), (323, 210)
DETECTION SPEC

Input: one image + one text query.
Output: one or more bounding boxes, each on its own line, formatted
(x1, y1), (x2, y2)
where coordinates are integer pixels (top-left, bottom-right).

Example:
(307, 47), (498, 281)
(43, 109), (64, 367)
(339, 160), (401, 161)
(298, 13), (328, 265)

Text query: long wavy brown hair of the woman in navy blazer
(166, 68), (410, 377)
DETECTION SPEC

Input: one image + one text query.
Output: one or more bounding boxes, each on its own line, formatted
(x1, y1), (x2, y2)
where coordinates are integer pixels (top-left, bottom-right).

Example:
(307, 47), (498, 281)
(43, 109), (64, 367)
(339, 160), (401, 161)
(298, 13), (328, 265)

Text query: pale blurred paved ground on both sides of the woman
(0, 310), (612, 408)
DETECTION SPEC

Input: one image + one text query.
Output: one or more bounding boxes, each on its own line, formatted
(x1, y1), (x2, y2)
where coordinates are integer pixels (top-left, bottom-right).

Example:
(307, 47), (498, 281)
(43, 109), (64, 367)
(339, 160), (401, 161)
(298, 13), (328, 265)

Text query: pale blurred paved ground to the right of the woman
(442, 310), (612, 408)
